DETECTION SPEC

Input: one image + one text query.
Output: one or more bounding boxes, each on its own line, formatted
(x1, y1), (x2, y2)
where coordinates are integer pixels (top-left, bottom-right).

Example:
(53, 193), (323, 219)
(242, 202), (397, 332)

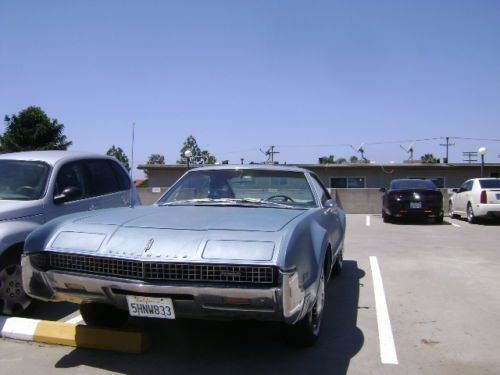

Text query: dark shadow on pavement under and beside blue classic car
(55, 260), (365, 375)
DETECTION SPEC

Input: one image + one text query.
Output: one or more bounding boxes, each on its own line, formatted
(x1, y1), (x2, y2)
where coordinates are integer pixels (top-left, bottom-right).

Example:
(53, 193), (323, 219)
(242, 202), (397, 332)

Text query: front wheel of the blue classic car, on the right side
(284, 267), (325, 347)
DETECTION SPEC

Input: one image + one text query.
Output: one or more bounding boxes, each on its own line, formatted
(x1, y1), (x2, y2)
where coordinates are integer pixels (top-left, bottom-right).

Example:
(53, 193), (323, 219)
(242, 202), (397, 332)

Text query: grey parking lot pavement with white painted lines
(0, 215), (500, 375)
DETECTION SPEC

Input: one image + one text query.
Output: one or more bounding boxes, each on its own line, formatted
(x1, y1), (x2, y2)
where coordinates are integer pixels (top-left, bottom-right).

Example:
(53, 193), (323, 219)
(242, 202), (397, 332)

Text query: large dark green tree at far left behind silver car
(0, 106), (73, 152)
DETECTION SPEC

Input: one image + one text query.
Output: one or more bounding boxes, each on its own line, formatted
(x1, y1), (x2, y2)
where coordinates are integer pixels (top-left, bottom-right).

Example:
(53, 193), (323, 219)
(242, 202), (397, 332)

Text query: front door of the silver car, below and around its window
(45, 160), (94, 221)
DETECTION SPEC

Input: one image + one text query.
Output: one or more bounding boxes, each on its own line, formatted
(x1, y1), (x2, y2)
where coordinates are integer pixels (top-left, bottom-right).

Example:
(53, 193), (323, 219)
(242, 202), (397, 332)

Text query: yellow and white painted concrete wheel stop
(0, 316), (150, 354)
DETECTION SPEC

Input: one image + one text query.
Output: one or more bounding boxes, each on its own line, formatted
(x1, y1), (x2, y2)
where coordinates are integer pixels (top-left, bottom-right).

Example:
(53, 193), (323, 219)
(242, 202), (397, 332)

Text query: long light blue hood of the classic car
(43, 206), (305, 261)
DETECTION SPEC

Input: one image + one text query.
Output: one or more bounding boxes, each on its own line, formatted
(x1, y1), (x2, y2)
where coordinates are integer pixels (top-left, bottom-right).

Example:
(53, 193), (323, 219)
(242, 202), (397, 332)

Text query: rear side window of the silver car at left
(85, 159), (121, 197)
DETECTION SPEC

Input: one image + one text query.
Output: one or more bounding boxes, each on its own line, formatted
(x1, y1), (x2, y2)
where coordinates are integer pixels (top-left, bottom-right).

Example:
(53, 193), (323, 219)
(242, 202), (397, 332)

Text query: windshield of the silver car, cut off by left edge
(0, 160), (49, 201)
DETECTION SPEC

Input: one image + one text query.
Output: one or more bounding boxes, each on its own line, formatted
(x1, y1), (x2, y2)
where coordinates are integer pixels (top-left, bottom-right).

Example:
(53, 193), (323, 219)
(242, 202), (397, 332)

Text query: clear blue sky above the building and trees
(0, 0), (500, 178)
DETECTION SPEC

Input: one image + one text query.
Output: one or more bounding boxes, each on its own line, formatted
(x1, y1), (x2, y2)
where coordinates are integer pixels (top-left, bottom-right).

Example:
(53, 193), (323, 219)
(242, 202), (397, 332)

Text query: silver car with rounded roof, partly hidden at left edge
(0, 151), (139, 314)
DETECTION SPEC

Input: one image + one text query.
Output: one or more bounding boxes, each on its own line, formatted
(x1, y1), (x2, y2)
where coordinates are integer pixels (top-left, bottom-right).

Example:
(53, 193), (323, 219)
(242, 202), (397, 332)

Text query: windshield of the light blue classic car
(158, 169), (316, 208)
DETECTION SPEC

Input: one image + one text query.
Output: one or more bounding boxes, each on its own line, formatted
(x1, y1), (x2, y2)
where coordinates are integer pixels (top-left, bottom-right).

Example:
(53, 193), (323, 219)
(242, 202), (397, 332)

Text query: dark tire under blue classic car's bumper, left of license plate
(80, 302), (129, 328)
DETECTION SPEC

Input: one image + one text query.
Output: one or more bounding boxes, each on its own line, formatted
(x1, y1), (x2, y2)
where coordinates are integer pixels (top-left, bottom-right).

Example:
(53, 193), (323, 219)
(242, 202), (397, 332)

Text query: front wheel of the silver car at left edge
(0, 264), (31, 315)
